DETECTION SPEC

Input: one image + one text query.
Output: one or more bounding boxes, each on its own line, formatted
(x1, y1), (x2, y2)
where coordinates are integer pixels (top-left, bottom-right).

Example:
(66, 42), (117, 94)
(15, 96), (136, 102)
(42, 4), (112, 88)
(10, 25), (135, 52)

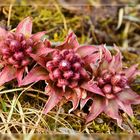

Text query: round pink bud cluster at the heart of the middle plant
(46, 49), (89, 88)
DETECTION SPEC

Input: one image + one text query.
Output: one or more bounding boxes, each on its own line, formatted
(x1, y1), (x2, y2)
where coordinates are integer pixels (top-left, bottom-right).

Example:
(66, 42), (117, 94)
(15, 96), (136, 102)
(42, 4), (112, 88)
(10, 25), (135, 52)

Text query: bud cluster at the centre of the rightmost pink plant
(97, 70), (127, 94)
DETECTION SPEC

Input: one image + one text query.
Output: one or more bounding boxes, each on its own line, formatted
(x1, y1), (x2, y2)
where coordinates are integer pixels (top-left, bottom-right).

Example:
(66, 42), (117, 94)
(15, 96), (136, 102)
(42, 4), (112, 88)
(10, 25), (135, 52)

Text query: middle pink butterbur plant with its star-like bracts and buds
(21, 32), (103, 114)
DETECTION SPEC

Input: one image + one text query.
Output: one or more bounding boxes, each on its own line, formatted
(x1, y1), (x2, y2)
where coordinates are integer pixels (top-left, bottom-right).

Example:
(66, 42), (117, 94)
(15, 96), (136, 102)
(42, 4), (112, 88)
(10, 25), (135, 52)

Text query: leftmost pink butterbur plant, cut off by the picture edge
(0, 17), (48, 85)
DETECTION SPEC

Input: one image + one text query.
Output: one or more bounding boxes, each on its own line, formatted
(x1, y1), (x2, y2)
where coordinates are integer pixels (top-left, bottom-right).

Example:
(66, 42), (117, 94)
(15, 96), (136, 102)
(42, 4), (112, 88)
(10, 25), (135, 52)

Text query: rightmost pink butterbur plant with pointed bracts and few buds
(83, 47), (140, 127)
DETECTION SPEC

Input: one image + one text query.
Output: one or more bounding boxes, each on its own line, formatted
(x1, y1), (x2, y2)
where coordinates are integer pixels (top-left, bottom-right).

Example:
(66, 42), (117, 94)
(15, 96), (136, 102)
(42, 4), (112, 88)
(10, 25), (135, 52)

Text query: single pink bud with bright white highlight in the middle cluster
(59, 60), (71, 71)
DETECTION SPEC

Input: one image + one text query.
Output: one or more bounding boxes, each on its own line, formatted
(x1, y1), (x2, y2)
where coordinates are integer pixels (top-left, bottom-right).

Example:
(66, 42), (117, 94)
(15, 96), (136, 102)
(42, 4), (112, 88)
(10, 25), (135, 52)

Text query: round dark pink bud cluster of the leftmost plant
(1, 33), (34, 68)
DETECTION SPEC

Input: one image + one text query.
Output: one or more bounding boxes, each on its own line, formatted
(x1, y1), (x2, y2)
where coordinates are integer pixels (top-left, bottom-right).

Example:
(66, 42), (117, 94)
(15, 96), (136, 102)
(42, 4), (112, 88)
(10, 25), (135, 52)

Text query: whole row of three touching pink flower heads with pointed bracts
(0, 17), (140, 127)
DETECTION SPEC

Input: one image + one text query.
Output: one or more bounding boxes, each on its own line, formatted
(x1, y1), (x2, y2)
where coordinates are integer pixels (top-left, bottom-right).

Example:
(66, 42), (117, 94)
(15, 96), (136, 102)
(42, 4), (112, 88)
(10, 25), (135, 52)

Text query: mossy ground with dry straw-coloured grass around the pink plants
(0, 0), (140, 139)
